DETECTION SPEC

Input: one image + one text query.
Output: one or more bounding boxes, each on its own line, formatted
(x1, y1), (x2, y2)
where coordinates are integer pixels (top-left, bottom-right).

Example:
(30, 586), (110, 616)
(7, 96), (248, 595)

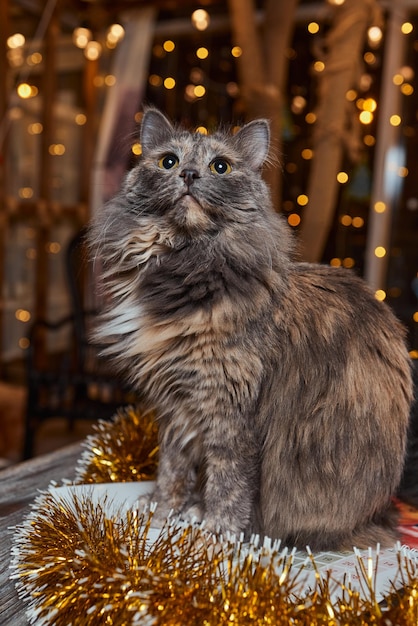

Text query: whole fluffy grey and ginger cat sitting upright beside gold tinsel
(91, 108), (412, 549)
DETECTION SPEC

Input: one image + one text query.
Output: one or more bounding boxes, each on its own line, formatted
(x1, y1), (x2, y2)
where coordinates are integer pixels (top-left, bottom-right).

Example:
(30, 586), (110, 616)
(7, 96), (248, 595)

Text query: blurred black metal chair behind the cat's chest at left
(23, 229), (138, 459)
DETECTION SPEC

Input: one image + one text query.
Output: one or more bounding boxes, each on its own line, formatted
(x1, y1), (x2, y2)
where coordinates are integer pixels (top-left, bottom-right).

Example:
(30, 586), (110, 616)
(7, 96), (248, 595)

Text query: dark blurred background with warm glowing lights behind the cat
(0, 0), (418, 456)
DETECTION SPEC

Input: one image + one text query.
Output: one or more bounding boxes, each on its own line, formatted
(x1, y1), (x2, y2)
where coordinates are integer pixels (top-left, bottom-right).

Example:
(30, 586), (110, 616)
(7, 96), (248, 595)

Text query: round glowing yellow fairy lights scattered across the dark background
(3, 0), (418, 356)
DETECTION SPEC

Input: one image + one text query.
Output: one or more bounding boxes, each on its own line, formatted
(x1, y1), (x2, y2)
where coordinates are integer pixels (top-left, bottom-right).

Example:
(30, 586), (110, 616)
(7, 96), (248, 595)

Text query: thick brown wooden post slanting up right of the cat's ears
(299, 0), (380, 262)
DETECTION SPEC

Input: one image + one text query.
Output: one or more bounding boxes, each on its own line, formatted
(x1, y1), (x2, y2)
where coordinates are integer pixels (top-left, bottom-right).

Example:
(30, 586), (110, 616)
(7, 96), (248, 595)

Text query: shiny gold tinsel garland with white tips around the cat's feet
(12, 408), (418, 626)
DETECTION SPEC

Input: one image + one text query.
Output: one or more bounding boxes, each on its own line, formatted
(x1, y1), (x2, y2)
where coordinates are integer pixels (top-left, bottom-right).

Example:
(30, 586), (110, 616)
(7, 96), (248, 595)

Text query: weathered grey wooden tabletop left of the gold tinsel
(0, 443), (81, 626)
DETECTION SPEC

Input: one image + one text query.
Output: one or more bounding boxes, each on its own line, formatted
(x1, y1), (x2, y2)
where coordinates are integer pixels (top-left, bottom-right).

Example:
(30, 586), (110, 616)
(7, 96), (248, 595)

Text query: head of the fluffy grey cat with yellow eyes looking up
(123, 108), (271, 237)
